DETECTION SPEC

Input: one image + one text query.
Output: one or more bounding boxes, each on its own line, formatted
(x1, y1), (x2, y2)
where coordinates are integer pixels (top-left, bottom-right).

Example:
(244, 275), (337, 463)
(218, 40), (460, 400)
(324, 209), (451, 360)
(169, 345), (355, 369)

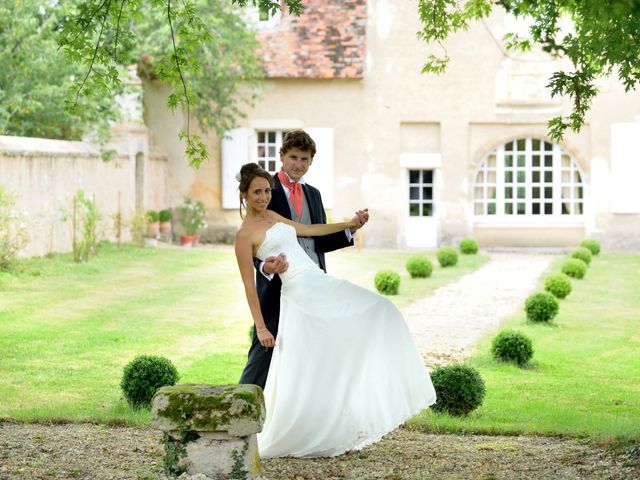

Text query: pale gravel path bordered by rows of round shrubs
(403, 253), (558, 367)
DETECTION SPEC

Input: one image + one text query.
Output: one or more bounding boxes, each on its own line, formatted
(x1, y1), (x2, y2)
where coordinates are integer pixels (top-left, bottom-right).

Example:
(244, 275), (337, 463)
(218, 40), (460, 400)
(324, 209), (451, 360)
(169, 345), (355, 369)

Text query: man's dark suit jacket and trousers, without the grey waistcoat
(240, 175), (353, 388)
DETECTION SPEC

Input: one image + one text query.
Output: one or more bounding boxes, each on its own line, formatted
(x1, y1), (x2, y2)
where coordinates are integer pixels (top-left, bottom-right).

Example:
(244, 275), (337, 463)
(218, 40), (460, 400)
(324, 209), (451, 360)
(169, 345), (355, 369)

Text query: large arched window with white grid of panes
(473, 138), (584, 218)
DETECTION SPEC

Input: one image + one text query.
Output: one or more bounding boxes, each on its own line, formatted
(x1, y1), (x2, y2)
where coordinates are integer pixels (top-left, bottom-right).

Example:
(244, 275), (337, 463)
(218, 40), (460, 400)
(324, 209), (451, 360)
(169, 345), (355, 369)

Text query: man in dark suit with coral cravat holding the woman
(240, 130), (369, 388)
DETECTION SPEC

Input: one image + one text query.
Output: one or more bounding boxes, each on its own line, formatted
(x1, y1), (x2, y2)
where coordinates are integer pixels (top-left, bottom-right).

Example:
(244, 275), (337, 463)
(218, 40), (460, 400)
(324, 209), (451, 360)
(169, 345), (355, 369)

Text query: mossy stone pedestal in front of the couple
(151, 384), (265, 480)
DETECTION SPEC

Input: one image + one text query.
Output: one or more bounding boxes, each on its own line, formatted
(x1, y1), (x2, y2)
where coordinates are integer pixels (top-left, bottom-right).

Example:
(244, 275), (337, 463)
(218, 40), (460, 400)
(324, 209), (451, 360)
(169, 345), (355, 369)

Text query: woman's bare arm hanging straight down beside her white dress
(235, 229), (275, 347)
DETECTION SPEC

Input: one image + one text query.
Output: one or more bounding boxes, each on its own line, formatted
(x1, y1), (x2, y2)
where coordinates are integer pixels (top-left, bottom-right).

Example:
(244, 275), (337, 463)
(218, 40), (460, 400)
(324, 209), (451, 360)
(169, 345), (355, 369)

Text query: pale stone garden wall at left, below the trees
(0, 125), (168, 256)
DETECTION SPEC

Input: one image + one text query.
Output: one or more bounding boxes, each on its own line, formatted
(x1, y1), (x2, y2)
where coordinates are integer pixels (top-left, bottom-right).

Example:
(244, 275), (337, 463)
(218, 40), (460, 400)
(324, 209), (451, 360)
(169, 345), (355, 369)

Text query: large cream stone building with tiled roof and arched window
(87, 0), (640, 249)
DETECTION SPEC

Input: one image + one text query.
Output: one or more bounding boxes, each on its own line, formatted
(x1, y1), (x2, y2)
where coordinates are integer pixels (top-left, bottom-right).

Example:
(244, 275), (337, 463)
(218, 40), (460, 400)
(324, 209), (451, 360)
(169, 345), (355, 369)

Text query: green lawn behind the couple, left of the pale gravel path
(0, 244), (487, 423)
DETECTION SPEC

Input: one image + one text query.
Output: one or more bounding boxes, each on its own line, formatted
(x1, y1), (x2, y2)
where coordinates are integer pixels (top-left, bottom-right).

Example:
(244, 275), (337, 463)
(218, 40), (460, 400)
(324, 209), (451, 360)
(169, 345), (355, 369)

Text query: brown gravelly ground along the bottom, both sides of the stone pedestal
(0, 422), (640, 480)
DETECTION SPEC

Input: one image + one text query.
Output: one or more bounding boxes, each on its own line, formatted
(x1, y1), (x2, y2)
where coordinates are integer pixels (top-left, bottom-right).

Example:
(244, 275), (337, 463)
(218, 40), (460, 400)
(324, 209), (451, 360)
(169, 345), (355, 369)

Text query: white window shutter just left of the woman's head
(221, 128), (253, 208)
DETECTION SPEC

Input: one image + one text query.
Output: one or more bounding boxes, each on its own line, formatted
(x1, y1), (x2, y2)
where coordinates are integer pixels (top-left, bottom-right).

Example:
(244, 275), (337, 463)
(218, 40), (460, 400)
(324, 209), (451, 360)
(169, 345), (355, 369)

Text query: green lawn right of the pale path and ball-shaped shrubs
(410, 254), (640, 440)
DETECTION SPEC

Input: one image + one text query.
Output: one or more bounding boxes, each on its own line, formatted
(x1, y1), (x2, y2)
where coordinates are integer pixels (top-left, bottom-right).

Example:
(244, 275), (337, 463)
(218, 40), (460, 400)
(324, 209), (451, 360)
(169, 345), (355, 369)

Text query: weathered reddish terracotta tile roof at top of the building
(258, 0), (367, 78)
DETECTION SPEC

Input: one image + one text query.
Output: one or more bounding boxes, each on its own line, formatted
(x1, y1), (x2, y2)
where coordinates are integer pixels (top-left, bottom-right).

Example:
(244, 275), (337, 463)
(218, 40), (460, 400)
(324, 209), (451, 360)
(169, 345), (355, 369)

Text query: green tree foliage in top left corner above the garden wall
(0, 0), (117, 140)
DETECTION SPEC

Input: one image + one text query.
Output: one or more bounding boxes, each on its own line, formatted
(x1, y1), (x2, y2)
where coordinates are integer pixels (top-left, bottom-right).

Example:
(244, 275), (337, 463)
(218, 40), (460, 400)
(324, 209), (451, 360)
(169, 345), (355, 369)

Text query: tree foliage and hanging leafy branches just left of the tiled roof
(60, 0), (272, 167)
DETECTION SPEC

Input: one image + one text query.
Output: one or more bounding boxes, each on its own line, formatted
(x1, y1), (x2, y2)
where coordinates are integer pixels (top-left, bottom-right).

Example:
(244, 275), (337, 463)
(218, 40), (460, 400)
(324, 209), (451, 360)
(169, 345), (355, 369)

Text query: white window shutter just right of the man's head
(304, 128), (334, 208)
